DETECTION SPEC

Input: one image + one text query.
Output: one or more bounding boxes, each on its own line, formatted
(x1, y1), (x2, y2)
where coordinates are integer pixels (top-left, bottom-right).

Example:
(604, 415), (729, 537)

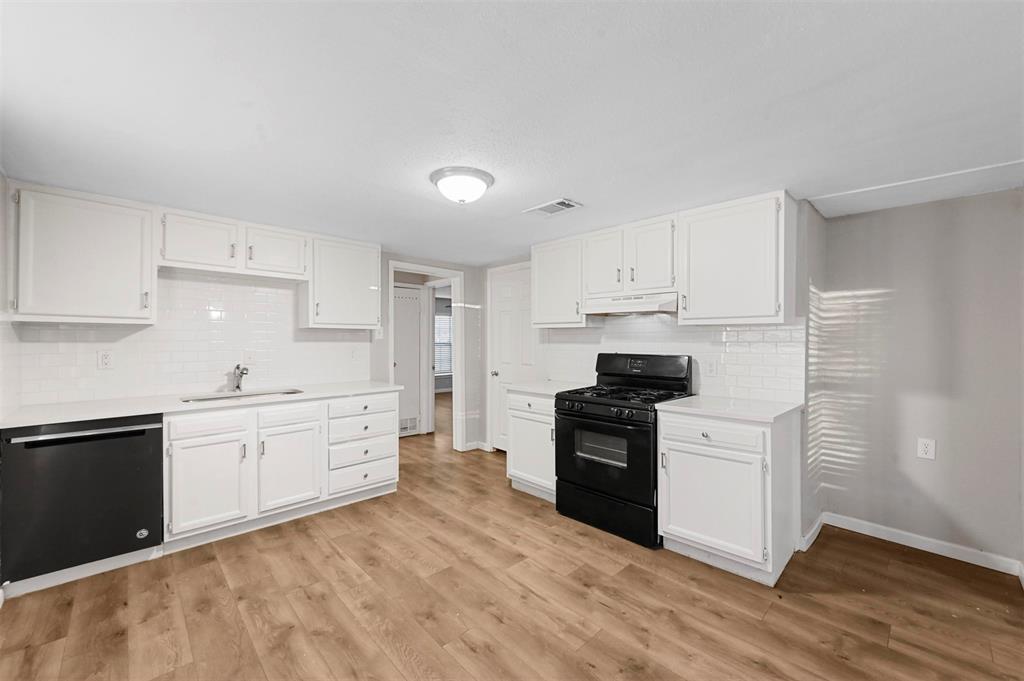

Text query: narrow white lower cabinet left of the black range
(505, 390), (555, 501)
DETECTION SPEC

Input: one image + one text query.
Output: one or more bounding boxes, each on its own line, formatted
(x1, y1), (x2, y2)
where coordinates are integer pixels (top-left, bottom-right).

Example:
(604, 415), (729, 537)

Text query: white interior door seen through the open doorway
(394, 284), (426, 434)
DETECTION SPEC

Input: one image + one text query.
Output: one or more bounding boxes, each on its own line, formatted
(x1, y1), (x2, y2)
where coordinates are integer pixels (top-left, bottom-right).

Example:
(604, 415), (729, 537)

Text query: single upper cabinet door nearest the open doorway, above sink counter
(310, 239), (381, 329)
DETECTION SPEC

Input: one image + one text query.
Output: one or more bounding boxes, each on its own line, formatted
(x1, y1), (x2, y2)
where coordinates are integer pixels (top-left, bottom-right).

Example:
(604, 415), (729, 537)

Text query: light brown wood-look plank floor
(0, 421), (1024, 681)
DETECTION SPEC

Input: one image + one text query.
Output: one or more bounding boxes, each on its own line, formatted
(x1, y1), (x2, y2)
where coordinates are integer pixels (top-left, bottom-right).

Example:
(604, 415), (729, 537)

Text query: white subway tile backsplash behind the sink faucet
(9, 268), (370, 405)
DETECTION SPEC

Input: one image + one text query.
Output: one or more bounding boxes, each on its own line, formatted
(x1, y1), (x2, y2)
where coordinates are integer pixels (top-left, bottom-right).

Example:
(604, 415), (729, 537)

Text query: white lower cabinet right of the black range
(657, 400), (800, 585)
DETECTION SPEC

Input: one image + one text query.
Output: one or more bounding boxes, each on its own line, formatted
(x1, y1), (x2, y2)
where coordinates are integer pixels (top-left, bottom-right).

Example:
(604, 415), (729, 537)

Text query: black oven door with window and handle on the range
(555, 412), (655, 507)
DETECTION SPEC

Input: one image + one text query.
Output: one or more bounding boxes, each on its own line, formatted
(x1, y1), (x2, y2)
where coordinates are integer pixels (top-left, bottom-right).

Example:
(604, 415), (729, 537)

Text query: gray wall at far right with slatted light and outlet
(808, 190), (1024, 556)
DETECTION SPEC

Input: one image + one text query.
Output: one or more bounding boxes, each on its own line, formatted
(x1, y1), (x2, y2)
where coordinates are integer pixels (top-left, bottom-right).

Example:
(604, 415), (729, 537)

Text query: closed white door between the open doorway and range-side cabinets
(487, 262), (542, 451)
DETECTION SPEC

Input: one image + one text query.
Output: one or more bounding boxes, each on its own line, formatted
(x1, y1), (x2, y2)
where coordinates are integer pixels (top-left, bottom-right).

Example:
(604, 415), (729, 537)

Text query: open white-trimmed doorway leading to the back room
(388, 261), (466, 452)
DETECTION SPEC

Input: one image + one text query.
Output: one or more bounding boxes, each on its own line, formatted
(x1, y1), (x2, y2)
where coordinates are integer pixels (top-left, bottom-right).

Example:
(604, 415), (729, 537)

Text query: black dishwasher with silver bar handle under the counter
(0, 414), (164, 584)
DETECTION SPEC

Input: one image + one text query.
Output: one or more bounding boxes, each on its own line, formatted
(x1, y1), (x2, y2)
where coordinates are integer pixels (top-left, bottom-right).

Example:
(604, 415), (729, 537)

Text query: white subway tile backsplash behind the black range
(540, 313), (805, 402)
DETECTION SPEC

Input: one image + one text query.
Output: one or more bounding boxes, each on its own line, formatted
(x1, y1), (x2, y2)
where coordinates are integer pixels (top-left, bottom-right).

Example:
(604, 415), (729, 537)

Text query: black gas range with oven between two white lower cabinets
(555, 352), (692, 547)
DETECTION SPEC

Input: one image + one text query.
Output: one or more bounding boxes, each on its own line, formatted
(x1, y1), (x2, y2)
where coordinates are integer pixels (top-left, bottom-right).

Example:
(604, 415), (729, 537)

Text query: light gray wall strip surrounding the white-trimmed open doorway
(370, 253), (487, 445)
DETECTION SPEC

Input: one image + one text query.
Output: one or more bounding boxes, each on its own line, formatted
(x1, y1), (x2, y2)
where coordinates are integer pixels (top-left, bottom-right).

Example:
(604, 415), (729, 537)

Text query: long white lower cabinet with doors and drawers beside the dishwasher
(164, 392), (398, 545)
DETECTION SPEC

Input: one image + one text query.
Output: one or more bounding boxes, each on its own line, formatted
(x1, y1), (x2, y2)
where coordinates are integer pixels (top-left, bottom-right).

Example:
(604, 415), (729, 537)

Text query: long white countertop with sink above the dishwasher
(0, 381), (402, 428)
